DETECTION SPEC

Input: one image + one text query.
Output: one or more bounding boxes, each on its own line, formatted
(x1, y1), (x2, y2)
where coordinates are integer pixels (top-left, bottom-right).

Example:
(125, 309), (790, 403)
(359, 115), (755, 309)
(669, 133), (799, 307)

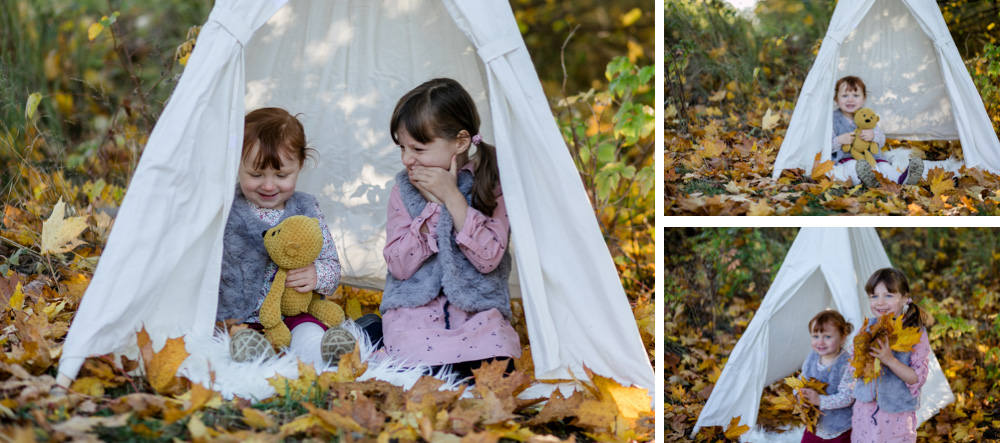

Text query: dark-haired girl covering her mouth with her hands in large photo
(380, 78), (521, 377)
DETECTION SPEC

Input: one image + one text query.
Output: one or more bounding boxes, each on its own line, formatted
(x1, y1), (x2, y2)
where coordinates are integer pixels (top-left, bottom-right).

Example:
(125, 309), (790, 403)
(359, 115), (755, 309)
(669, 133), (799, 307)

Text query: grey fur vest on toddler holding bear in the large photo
(215, 186), (319, 322)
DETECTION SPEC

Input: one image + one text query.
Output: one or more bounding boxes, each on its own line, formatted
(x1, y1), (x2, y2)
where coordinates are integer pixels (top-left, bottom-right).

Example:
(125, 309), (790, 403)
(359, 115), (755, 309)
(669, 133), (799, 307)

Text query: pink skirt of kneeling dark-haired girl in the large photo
(382, 295), (521, 366)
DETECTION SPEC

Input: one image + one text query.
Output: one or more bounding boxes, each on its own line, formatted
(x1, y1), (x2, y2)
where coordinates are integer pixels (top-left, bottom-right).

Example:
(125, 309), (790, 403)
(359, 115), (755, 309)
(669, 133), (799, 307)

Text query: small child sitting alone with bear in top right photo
(831, 75), (924, 188)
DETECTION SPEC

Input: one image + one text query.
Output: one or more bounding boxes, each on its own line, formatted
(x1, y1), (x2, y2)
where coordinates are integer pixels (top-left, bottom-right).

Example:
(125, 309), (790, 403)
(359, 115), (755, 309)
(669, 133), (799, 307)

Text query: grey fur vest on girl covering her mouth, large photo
(379, 170), (511, 320)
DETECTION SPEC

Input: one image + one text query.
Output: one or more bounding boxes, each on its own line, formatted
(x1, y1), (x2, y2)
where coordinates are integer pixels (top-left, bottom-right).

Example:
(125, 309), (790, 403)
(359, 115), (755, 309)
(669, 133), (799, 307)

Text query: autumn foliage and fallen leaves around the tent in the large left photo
(0, 0), (656, 441)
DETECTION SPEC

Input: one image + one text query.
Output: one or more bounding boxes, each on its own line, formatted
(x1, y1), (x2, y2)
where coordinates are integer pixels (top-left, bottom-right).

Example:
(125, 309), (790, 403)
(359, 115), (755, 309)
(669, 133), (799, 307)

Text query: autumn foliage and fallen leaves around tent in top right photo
(663, 0), (1000, 215)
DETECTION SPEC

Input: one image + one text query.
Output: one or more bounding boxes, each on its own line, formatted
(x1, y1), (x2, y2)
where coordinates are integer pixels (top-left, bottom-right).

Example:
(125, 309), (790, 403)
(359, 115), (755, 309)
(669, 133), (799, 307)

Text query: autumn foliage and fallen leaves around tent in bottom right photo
(663, 228), (1000, 442)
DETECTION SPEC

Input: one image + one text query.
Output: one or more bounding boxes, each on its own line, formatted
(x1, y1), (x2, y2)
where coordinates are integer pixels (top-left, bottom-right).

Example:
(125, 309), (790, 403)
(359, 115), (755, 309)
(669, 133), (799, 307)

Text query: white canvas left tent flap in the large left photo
(59, 0), (282, 382)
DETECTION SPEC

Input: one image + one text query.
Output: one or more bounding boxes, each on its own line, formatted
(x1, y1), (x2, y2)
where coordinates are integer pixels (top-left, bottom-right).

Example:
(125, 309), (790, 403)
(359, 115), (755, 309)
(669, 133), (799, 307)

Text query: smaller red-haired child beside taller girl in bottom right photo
(802, 310), (854, 443)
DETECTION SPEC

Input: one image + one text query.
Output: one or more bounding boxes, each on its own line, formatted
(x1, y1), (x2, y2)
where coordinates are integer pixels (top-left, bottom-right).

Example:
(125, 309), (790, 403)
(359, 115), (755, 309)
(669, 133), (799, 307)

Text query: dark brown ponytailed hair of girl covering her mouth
(389, 78), (500, 216)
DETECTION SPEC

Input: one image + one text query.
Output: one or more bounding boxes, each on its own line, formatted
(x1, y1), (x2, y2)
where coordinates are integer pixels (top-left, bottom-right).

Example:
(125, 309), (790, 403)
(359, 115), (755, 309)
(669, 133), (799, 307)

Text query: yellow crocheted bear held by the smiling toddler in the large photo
(260, 215), (344, 350)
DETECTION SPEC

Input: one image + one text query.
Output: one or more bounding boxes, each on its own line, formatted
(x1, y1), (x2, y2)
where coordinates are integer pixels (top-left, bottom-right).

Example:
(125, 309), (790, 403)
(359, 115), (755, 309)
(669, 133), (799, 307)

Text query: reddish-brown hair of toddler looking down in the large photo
(240, 108), (312, 169)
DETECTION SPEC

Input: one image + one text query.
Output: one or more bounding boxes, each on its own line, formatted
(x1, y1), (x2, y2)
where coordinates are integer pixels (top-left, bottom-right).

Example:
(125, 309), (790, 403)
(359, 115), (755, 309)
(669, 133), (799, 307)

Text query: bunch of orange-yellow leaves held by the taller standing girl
(851, 313), (920, 383)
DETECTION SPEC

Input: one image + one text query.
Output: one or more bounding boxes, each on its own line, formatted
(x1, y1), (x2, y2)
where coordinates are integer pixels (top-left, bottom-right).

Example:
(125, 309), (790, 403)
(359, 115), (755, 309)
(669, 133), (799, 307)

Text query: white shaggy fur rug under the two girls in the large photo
(177, 320), (579, 402)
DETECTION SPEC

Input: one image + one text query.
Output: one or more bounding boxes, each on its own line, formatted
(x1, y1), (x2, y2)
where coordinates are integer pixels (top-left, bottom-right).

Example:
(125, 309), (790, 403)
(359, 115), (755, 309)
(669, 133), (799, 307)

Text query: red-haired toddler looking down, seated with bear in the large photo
(216, 108), (354, 365)
